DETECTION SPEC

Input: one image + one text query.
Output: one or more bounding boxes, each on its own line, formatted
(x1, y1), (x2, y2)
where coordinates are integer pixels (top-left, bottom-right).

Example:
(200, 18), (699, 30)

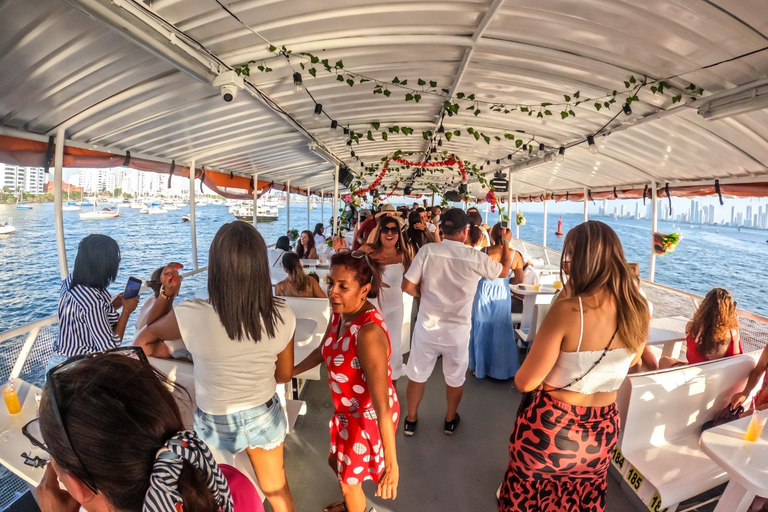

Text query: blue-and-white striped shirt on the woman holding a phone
(53, 275), (120, 357)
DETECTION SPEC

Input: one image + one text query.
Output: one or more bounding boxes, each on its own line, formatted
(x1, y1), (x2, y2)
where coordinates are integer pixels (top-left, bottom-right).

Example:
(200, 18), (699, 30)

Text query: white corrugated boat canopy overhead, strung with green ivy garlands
(0, 0), (768, 199)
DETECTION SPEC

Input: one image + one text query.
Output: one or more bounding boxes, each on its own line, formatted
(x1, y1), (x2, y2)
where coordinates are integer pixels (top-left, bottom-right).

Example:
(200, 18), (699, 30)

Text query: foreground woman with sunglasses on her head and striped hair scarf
(37, 347), (264, 512)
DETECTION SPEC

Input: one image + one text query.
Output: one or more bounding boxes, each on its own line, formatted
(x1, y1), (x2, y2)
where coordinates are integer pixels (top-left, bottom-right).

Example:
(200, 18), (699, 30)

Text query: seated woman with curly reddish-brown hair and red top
(659, 288), (743, 369)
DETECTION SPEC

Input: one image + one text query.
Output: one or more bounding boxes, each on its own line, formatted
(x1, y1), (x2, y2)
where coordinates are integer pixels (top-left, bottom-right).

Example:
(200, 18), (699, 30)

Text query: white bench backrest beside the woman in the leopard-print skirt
(616, 351), (760, 453)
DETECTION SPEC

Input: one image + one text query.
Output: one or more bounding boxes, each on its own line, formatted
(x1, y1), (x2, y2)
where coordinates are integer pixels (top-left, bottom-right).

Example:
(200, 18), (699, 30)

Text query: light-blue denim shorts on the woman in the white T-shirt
(195, 394), (288, 453)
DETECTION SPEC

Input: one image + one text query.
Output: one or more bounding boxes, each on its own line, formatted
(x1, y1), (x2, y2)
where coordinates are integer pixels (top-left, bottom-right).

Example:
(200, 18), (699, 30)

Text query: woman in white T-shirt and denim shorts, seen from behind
(147, 221), (296, 512)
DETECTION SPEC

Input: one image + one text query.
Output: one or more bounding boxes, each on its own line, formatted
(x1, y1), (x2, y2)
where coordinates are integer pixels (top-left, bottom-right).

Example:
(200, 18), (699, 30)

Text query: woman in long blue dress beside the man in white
(469, 224), (522, 380)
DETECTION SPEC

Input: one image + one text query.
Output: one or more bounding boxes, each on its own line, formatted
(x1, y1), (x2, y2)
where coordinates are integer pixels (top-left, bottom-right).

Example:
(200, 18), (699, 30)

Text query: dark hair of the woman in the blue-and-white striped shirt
(69, 235), (120, 290)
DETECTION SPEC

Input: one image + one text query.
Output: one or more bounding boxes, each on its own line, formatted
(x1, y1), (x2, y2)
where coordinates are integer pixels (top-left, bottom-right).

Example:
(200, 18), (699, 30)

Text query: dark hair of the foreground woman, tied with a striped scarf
(39, 354), (219, 512)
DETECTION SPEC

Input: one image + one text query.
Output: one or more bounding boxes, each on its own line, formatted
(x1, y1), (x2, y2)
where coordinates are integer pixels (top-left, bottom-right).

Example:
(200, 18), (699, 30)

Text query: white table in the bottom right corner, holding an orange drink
(699, 410), (768, 512)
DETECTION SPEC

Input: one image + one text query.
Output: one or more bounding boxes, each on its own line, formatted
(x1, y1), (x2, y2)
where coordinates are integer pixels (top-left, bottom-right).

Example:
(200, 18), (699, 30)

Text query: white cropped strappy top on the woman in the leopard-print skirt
(544, 297), (636, 395)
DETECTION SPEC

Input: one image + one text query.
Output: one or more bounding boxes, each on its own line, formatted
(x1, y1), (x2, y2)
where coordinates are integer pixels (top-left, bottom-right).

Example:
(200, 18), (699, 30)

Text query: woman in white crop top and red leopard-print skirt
(498, 221), (650, 512)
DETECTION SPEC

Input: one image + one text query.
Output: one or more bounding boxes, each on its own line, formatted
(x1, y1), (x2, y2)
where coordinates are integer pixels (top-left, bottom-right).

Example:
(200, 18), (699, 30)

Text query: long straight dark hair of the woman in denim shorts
(208, 221), (282, 342)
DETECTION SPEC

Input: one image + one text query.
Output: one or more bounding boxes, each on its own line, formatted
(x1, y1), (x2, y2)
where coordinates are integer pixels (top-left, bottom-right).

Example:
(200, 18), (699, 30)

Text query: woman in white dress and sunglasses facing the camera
(360, 216), (412, 381)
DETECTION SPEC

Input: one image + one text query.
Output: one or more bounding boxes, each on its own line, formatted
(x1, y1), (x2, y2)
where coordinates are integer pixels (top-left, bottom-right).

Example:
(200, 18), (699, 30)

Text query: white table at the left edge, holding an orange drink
(0, 379), (48, 489)
